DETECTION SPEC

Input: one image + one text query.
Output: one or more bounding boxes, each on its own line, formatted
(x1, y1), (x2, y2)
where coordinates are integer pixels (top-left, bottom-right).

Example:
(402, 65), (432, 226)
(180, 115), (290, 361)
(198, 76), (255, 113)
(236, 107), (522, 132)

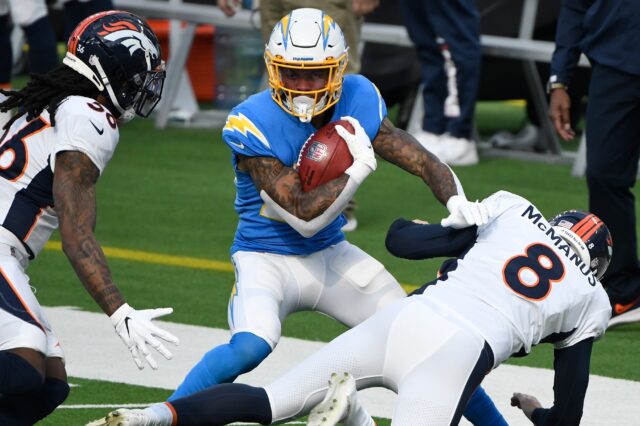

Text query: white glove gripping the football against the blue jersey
(336, 117), (377, 185)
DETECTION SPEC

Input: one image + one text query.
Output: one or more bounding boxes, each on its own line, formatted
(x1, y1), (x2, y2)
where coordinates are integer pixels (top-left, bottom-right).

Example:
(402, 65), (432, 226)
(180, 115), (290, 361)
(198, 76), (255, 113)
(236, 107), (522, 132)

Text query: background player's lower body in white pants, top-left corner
(0, 0), (58, 128)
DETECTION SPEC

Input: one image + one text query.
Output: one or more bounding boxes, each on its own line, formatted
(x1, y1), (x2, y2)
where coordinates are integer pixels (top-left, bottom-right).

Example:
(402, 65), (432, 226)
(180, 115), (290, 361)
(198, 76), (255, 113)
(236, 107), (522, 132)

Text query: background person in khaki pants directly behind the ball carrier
(218, 0), (380, 232)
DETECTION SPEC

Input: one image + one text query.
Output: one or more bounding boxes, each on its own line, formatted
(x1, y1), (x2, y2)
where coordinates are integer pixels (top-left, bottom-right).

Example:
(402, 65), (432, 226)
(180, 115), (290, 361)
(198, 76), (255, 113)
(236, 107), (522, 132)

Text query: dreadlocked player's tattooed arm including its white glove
(53, 151), (178, 368)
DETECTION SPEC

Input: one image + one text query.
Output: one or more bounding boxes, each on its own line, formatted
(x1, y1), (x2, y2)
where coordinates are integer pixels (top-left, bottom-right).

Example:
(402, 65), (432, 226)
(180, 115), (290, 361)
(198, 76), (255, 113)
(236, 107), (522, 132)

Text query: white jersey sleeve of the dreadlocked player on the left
(51, 97), (120, 174)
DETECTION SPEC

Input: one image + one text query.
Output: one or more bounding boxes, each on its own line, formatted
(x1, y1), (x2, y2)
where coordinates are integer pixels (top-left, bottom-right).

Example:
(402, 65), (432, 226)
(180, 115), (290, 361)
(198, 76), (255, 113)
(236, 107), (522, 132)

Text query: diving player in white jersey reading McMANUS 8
(85, 191), (612, 426)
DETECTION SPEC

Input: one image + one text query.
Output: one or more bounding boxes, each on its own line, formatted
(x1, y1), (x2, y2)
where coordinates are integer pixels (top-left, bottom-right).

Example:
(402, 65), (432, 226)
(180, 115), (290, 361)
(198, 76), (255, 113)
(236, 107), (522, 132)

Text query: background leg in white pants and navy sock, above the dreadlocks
(9, 0), (58, 74)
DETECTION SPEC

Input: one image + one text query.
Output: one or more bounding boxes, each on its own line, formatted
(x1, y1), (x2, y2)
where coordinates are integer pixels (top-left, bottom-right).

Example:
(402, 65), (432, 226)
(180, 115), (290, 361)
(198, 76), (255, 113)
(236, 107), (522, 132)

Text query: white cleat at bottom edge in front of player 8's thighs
(307, 373), (375, 426)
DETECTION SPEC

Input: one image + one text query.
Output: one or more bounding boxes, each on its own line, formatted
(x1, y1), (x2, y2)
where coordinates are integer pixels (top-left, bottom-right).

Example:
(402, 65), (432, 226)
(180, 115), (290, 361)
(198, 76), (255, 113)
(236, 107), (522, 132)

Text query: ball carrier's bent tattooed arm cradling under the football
(238, 155), (349, 221)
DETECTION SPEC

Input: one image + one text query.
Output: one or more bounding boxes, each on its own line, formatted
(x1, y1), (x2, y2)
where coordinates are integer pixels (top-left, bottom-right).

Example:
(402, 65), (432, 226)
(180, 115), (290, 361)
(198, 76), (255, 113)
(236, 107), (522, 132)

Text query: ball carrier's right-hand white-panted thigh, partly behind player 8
(313, 241), (406, 327)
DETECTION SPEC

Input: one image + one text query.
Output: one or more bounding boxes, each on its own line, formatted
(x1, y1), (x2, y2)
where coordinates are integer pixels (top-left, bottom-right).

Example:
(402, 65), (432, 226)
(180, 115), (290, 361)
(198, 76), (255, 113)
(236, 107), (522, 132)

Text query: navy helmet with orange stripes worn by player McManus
(549, 210), (613, 279)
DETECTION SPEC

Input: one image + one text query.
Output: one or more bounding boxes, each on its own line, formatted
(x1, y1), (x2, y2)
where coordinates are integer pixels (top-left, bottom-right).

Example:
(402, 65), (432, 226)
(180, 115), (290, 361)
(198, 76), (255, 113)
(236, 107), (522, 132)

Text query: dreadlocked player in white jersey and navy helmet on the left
(0, 11), (177, 425)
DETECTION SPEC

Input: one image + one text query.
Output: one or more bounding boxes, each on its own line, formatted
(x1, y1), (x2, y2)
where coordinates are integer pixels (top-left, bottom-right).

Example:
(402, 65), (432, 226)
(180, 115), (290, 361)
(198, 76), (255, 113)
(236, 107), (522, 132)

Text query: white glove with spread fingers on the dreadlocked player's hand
(109, 303), (179, 370)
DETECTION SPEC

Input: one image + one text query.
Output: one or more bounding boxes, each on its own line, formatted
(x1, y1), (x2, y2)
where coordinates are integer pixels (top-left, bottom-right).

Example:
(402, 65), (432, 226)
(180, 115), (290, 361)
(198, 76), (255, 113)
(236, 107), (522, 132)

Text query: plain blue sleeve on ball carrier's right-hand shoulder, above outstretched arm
(343, 75), (387, 140)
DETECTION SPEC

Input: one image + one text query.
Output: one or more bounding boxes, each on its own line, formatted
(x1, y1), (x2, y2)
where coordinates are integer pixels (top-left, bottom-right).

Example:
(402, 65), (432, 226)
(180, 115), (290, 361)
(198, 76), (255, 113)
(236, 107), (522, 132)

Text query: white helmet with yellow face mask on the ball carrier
(264, 8), (348, 123)
